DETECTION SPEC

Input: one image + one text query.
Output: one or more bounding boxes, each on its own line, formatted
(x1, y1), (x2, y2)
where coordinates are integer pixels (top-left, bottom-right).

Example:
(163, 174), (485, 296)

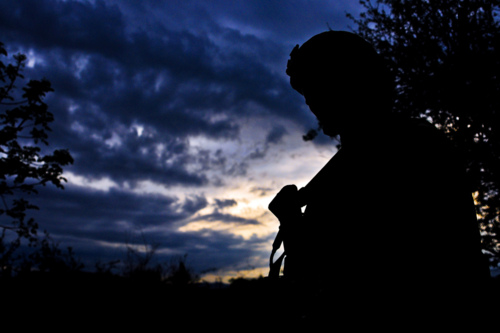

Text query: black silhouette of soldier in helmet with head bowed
(269, 31), (489, 308)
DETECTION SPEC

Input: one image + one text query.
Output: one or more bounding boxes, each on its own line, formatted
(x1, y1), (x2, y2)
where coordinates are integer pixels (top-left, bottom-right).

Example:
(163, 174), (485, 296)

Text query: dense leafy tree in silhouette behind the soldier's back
(347, 0), (500, 266)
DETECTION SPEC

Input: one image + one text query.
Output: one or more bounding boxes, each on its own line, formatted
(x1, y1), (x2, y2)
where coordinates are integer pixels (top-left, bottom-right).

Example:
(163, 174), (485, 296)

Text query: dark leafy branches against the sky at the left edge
(0, 43), (73, 276)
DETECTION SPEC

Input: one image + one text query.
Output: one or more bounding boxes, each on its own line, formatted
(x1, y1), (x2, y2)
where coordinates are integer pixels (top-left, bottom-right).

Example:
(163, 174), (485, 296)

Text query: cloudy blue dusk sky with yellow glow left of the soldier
(0, 0), (361, 281)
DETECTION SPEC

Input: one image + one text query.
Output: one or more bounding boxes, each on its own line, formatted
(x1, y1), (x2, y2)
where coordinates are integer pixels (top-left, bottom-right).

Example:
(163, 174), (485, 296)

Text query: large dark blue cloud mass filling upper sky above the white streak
(0, 0), (312, 185)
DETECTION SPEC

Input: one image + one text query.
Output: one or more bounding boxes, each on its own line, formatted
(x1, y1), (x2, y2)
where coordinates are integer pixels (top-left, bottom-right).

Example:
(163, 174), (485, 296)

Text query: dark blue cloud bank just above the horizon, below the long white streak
(30, 186), (268, 271)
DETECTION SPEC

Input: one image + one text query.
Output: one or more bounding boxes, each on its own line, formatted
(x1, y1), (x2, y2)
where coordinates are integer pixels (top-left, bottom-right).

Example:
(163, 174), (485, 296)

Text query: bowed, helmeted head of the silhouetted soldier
(286, 30), (392, 136)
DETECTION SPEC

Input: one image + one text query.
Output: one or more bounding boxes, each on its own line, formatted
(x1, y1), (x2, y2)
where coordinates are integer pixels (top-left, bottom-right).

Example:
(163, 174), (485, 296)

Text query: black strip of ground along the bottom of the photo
(0, 274), (500, 333)
